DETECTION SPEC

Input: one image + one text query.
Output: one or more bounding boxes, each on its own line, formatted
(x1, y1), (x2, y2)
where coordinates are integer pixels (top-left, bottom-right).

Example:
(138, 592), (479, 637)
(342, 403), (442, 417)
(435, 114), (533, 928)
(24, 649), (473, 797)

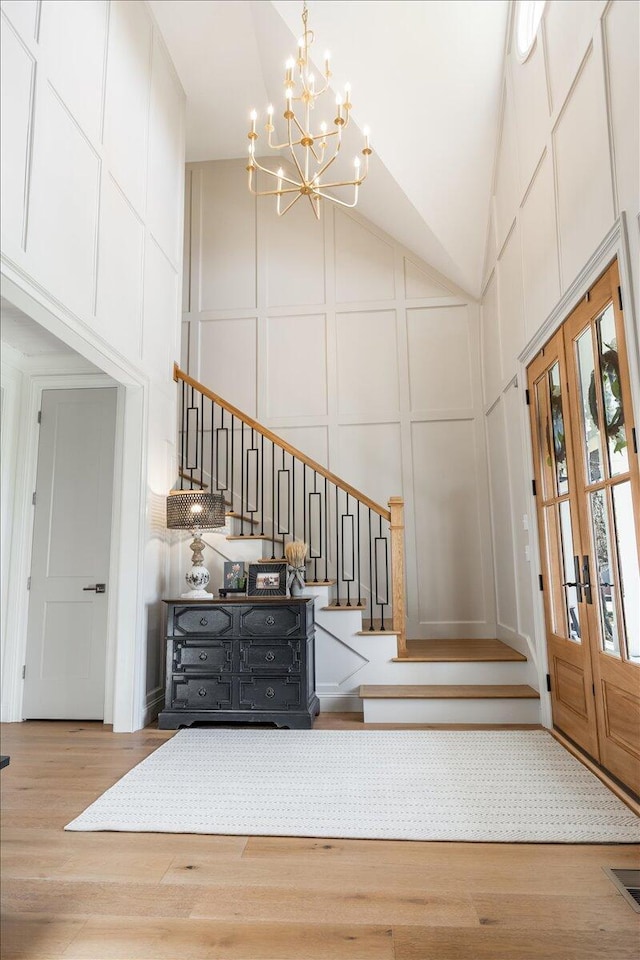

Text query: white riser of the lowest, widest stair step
(363, 698), (540, 723)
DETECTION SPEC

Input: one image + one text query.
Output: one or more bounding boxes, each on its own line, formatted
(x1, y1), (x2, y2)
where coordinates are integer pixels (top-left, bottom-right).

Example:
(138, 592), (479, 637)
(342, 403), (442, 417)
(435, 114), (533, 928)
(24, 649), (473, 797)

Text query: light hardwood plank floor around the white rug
(0, 715), (640, 960)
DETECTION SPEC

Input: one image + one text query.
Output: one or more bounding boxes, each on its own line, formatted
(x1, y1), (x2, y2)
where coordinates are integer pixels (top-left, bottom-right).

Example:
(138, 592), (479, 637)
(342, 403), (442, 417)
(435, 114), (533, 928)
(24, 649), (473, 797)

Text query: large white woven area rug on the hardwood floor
(66, 728), (640, 843)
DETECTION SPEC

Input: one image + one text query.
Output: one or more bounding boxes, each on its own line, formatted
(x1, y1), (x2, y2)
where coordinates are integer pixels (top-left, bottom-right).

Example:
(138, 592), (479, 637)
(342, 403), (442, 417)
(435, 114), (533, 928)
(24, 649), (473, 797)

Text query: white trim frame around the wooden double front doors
(518, 212), (640, 729)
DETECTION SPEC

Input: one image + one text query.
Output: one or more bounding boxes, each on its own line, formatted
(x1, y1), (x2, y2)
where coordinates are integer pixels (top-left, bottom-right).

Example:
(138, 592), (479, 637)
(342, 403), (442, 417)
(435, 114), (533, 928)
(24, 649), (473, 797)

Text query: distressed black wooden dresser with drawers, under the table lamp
(158, 596), (320, 730)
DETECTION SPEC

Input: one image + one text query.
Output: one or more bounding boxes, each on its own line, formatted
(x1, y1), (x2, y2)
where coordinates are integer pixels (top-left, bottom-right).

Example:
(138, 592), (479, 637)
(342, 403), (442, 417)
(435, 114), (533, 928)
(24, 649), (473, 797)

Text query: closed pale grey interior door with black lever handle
(23, 387), (116, 720)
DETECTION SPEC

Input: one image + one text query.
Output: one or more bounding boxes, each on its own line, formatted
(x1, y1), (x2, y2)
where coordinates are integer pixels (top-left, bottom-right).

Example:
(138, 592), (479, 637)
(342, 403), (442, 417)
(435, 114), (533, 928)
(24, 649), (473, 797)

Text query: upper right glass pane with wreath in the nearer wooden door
(598, 303), (629, 477)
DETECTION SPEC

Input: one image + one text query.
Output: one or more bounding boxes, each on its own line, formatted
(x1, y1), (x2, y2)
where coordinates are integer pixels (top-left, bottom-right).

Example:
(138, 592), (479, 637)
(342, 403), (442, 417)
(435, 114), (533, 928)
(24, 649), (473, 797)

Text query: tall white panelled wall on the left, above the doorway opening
(1, 0), (184, 729)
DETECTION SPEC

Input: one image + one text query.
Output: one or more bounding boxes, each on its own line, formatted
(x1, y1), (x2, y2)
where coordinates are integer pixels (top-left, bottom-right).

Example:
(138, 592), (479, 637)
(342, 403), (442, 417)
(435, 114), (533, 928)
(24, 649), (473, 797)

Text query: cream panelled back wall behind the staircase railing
(183, 160), (495, 637)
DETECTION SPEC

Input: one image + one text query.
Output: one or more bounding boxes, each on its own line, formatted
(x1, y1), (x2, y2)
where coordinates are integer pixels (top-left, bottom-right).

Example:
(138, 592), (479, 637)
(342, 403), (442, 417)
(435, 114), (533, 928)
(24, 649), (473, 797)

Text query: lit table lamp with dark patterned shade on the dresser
(167, 490), (225, 600)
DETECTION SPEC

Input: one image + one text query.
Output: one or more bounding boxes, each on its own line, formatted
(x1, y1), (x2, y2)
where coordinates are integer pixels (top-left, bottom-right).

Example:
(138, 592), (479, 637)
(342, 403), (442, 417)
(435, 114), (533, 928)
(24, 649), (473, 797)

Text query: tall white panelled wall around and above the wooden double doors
(482, 0), (640, 688)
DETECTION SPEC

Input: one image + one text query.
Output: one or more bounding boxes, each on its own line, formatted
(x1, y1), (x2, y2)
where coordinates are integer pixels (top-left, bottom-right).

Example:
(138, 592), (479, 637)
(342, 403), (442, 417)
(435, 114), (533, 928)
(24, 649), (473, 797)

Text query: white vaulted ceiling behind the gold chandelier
(149, 0), (509, 295)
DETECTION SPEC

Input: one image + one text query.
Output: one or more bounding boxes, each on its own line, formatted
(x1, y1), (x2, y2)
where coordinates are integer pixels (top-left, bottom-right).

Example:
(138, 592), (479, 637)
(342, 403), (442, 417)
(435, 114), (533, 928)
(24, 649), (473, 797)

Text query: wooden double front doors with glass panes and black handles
(528, 263), (640, 793)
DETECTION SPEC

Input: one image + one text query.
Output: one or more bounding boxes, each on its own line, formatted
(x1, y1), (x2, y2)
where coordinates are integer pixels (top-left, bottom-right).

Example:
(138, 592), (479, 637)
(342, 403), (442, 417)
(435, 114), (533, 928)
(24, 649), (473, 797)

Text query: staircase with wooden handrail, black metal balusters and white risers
(174, 367), (540, 725)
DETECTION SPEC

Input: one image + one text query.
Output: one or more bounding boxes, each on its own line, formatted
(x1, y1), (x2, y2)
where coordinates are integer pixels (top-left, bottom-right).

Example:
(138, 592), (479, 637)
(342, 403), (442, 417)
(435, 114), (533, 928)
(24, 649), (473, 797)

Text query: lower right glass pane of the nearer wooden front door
(613, 480), (640, 663)
